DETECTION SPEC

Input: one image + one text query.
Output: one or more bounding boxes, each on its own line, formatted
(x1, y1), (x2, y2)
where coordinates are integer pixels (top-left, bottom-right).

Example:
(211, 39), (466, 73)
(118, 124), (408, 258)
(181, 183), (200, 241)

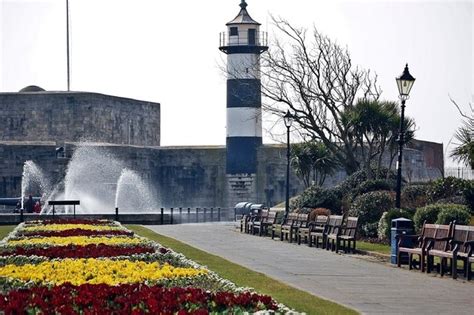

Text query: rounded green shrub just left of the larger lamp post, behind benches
(349, 191), (393, 237)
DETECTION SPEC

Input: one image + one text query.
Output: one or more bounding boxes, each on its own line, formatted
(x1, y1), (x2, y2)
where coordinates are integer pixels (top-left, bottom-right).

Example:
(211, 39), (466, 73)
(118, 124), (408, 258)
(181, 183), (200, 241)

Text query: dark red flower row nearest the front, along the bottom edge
(0, 284), (277, 314)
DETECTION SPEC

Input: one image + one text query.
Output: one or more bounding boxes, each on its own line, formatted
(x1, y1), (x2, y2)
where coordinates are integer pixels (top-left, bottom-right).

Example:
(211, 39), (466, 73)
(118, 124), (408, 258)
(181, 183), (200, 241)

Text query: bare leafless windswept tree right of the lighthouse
(260, 17), (381, 174)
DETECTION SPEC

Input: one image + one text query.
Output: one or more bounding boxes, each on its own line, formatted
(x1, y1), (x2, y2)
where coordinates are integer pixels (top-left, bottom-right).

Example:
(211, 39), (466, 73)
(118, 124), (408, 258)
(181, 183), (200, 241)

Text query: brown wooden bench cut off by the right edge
(426, 222), (474, 279)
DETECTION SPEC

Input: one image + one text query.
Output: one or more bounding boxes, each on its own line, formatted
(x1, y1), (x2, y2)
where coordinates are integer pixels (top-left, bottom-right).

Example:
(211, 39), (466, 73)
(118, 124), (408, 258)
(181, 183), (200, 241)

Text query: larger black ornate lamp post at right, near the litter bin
(395, 64), (415, 208)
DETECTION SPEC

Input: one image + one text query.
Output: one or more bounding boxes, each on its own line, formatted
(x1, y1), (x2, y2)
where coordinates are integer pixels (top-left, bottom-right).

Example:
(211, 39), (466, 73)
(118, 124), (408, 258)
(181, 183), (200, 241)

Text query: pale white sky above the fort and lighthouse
(0, 0), (474, 166)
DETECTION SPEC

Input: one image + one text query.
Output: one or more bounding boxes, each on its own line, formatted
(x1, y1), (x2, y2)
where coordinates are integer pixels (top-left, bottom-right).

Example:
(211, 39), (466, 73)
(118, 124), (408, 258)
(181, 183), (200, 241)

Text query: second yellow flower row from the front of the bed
(7, 236), (147, 246)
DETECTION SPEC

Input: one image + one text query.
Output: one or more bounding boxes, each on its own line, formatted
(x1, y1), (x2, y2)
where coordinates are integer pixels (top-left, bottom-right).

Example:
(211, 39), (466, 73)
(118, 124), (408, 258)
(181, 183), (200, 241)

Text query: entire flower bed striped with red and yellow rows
(0, 220), (288, 314)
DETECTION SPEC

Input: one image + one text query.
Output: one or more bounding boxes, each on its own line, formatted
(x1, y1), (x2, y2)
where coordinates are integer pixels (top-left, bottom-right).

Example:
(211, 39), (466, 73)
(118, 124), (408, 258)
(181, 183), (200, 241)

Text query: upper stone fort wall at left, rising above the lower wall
(0, 92), (160, 146)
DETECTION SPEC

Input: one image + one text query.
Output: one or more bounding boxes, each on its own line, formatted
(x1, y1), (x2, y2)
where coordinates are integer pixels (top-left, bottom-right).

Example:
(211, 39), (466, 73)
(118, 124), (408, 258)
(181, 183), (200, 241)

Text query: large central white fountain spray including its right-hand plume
(37, 143), (155, 214)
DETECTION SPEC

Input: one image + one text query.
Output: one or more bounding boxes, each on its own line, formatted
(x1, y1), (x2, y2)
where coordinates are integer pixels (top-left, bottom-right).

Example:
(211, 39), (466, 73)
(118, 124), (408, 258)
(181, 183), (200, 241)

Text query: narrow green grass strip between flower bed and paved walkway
(127, 225), (358, 314)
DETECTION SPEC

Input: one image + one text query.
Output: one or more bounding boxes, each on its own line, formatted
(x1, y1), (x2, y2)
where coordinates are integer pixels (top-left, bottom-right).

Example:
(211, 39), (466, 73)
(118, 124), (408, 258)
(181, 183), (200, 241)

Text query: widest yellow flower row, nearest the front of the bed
(0, 258), (208, 286)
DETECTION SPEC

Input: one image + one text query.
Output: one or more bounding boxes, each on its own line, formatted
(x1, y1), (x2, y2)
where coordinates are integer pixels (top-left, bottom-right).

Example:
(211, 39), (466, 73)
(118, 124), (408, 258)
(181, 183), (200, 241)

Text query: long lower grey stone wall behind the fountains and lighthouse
(0, 141), (442, 208)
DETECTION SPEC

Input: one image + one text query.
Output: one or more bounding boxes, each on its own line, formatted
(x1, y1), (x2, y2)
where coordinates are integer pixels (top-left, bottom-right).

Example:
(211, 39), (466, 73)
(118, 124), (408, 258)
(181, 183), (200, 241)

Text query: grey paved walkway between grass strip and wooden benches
(148, 223), (474, 314)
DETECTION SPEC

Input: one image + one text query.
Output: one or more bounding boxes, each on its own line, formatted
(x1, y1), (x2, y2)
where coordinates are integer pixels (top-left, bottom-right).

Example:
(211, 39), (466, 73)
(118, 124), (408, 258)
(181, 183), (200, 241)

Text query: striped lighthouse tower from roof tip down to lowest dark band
(219, 0), (268, 175)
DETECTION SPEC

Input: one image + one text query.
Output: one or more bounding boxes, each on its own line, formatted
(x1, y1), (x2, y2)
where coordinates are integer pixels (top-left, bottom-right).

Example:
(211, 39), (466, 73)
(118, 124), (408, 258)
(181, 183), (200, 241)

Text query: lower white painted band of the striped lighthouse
(227, 107), (262, 137)
